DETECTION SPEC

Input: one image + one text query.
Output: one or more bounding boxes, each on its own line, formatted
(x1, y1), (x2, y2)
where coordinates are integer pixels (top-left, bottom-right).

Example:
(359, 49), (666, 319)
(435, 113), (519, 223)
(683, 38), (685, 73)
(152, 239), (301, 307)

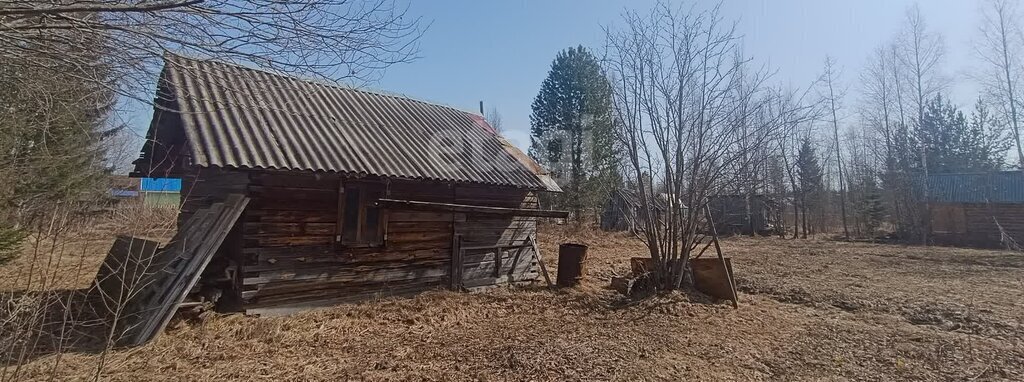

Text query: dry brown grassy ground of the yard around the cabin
(2, 227), (1024, 381)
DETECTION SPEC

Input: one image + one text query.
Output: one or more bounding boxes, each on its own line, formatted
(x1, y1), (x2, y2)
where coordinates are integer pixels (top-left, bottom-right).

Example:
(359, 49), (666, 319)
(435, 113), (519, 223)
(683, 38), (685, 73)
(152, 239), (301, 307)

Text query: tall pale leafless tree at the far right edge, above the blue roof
(975, 0), (1024, 169)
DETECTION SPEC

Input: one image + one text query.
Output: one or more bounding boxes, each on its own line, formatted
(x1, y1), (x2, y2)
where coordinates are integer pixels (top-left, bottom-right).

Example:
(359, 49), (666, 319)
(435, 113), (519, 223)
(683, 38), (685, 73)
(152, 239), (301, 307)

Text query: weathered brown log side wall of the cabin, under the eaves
(182, 171), (539, 313)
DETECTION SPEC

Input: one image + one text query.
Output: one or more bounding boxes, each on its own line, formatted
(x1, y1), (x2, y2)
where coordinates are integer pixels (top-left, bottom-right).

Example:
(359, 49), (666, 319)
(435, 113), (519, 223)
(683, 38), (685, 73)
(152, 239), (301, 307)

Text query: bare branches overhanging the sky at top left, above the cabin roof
(0, 0), (421, 100)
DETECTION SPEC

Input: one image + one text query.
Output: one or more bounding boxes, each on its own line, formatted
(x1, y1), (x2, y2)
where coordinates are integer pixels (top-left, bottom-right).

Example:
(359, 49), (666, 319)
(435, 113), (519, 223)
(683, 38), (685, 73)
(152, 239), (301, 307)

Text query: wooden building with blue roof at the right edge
(928, 171), (1024, 247)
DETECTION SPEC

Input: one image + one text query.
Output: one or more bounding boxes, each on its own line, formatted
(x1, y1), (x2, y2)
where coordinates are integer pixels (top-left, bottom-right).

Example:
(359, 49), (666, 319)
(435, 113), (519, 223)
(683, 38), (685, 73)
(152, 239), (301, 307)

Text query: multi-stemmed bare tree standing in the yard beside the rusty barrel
(605, 2), (802, 290)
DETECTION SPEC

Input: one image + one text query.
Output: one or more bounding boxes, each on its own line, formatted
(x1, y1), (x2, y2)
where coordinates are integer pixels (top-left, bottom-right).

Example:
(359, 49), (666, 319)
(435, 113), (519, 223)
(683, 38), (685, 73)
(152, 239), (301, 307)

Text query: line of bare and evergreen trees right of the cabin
(529, 0), (1024, 260)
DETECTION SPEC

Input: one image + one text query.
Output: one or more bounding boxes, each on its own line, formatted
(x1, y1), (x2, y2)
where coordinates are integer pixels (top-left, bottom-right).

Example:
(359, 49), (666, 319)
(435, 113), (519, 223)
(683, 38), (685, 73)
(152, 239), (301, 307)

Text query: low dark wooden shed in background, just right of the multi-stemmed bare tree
(708, 195), (779, 235)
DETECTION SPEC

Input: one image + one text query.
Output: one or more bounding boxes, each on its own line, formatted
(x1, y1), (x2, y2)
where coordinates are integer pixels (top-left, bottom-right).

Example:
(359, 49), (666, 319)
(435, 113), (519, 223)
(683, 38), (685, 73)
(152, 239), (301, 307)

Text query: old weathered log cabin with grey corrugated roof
(132, 54), (564, 314)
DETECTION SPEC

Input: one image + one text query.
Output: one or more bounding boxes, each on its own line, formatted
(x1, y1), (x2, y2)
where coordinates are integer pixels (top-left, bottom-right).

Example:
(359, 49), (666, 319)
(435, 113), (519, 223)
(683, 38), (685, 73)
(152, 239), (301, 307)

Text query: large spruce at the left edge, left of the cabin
(0, 37), (118, 263)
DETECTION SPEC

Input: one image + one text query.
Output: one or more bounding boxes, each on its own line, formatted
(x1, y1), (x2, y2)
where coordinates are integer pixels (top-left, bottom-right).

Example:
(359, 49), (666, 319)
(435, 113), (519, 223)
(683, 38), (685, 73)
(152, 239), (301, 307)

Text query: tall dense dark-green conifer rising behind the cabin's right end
(529, 46), (621, 218)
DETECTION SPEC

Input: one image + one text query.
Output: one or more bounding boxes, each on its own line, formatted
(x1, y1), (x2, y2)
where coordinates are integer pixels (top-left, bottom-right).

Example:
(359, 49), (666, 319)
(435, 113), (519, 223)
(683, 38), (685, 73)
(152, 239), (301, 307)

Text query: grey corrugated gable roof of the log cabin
(135, 54), (560, 190)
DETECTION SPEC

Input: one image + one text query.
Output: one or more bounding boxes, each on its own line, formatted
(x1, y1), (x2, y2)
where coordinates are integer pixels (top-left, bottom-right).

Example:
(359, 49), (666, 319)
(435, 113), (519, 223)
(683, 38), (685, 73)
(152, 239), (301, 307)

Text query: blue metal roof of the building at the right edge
(919, 171), (1024, 203)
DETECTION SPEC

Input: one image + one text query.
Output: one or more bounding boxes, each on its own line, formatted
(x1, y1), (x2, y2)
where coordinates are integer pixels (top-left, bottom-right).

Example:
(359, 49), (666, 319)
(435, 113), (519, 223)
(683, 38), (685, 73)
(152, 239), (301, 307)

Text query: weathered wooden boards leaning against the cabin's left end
(92, 195), (249, 346)
